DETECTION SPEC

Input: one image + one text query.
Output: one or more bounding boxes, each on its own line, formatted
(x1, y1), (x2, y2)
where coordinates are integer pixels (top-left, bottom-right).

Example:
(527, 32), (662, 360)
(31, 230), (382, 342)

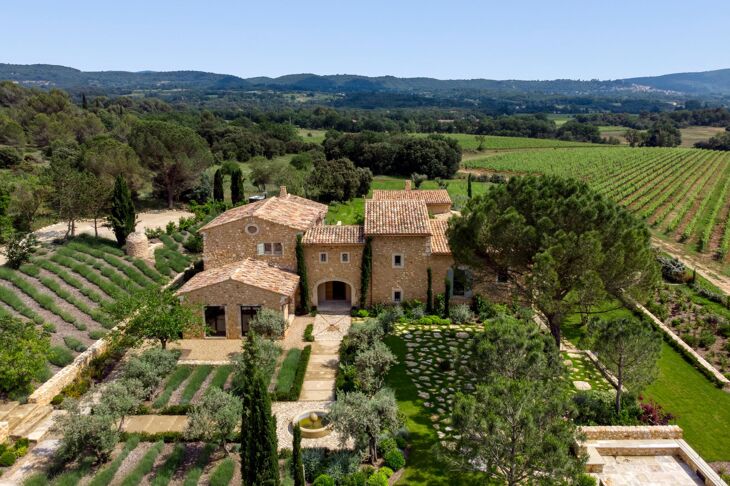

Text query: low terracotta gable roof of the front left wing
(177, 258), (299, 297)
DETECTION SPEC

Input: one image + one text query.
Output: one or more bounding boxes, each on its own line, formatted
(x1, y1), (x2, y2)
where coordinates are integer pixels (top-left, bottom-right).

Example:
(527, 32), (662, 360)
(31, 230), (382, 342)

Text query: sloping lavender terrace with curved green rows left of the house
(0, 229), (199, 372)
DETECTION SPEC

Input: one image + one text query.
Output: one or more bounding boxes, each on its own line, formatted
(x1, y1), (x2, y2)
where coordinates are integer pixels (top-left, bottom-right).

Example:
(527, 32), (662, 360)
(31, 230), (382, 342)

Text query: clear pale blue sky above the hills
(0, 0), (730, 79)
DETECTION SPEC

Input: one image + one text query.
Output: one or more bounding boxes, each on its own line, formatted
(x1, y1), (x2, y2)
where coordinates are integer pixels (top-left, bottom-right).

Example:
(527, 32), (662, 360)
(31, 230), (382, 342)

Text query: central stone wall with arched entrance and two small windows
(304, 244), (365, 306)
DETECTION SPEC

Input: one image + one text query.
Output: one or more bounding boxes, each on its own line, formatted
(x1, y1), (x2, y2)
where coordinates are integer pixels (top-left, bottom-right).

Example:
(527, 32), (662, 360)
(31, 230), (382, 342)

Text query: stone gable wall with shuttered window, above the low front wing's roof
(202, 217), (301, 271)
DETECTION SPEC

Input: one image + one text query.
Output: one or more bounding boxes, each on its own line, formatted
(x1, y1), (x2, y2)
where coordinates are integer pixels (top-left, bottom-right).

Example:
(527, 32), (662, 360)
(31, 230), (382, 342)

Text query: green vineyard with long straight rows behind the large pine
(464, 147), (730, 261)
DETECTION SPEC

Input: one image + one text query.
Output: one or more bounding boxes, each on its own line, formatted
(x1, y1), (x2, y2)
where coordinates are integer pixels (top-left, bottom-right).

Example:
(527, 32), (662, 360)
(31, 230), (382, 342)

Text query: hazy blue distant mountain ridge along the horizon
(0, 64), (730, 97)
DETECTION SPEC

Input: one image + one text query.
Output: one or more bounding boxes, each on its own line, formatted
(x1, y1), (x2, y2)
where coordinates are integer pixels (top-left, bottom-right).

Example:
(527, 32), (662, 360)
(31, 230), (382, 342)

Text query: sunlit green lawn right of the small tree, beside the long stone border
(646, 343), (730, 462)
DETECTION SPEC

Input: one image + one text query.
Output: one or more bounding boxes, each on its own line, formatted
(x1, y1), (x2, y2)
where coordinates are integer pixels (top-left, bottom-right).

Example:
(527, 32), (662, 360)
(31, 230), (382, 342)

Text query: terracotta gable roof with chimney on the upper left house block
(199, 194), (327, 231)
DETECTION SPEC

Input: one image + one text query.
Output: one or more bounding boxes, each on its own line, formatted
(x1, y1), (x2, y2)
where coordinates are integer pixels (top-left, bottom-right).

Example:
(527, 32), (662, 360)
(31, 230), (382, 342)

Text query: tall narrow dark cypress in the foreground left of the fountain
(239, 333), (279, 486)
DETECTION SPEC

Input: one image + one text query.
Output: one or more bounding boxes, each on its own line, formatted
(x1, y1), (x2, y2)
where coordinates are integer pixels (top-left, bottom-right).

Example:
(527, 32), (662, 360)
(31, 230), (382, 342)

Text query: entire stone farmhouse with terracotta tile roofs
(178, 181), (486, 339)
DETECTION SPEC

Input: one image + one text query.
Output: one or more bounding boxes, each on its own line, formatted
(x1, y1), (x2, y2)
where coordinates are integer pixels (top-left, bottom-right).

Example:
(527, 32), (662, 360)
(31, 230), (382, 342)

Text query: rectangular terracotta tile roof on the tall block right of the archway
(365, 199), (431, 235)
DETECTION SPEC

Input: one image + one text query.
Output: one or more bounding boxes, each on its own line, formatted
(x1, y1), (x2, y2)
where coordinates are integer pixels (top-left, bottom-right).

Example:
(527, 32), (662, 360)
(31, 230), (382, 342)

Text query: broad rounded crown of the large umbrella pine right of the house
(447, 176), (658, 343)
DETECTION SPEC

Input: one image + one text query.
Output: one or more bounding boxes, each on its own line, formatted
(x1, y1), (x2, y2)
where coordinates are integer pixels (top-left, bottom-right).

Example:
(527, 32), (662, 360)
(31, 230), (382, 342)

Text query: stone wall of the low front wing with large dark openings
(184, 280), (296, 339)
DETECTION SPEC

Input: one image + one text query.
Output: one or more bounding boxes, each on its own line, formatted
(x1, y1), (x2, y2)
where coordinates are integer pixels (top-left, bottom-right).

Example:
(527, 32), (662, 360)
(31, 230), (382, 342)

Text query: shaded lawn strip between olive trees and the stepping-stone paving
(384, 336), (487, 486)
